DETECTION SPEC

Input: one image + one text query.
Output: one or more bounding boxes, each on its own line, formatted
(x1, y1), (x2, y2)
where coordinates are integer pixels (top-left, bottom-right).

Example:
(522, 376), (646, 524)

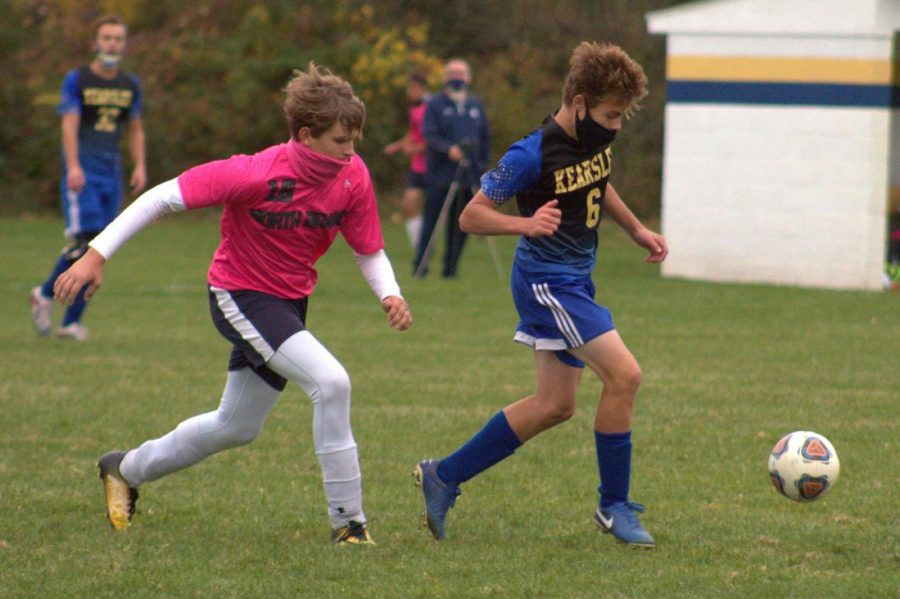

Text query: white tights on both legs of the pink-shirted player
(119, 331), (366, 528)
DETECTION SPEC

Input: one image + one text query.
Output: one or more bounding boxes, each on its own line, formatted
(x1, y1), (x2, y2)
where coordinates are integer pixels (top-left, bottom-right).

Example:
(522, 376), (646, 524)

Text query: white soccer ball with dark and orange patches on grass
(769, 431), (841, 501)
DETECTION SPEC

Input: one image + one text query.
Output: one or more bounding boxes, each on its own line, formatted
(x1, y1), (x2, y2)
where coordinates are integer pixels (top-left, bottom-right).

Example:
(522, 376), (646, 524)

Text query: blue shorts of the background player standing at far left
(60, 169), (122, 237)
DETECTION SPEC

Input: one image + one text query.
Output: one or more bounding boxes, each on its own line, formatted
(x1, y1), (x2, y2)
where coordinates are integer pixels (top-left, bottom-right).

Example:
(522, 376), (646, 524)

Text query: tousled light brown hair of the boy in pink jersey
(284, 61), (366, 139)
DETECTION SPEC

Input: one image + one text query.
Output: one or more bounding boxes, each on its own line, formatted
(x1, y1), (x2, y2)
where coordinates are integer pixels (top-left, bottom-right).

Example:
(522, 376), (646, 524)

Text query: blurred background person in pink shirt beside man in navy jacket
(384, 73), (428, 247)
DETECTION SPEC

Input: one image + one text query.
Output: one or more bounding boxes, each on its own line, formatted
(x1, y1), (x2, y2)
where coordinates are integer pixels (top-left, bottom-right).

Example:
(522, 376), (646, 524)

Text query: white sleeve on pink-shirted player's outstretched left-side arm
(88, 179), (187, 260)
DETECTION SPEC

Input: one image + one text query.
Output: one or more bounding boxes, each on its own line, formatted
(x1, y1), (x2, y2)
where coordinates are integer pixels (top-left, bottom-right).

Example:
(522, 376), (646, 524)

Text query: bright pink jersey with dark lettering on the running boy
(178, 140), (384, 299)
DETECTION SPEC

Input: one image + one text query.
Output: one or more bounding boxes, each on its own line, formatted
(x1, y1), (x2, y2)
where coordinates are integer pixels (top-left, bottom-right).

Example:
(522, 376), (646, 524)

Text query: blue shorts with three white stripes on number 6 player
(512, 264), (615, 368)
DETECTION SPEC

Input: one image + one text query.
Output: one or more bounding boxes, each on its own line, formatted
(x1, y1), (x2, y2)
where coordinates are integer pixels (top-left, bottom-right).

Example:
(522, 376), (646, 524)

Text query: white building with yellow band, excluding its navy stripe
(648, 0), (900, 289)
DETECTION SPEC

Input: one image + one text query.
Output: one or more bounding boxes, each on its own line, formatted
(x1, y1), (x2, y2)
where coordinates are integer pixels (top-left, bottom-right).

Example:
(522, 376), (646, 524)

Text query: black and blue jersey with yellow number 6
(481, 116), (612, 275)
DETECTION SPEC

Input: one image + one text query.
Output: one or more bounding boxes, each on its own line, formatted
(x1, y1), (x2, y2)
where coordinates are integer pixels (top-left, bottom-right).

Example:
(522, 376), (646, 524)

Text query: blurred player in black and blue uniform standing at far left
(29, 15), (147, 341)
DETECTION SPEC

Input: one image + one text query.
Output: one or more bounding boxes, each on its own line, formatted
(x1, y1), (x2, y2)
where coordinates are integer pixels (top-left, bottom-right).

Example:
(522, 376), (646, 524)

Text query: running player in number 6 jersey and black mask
(415, 42), (668, 547)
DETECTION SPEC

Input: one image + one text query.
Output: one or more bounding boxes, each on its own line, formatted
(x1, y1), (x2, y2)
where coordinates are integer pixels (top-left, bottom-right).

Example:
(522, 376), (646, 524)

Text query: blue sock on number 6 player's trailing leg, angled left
(437, 411), (522, 485)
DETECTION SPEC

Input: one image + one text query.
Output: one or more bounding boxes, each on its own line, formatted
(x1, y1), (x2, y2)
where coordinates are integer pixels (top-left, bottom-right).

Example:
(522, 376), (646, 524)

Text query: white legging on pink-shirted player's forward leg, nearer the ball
(267, 331), (366, 528)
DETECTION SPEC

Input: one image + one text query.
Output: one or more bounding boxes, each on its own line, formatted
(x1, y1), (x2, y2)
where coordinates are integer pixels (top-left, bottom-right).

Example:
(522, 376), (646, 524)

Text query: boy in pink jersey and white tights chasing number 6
(54, 63), (412, 544)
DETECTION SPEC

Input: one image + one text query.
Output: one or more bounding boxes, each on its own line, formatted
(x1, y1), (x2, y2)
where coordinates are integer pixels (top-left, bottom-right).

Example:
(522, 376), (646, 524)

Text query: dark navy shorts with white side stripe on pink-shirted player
(209, 286), (308, 391)
